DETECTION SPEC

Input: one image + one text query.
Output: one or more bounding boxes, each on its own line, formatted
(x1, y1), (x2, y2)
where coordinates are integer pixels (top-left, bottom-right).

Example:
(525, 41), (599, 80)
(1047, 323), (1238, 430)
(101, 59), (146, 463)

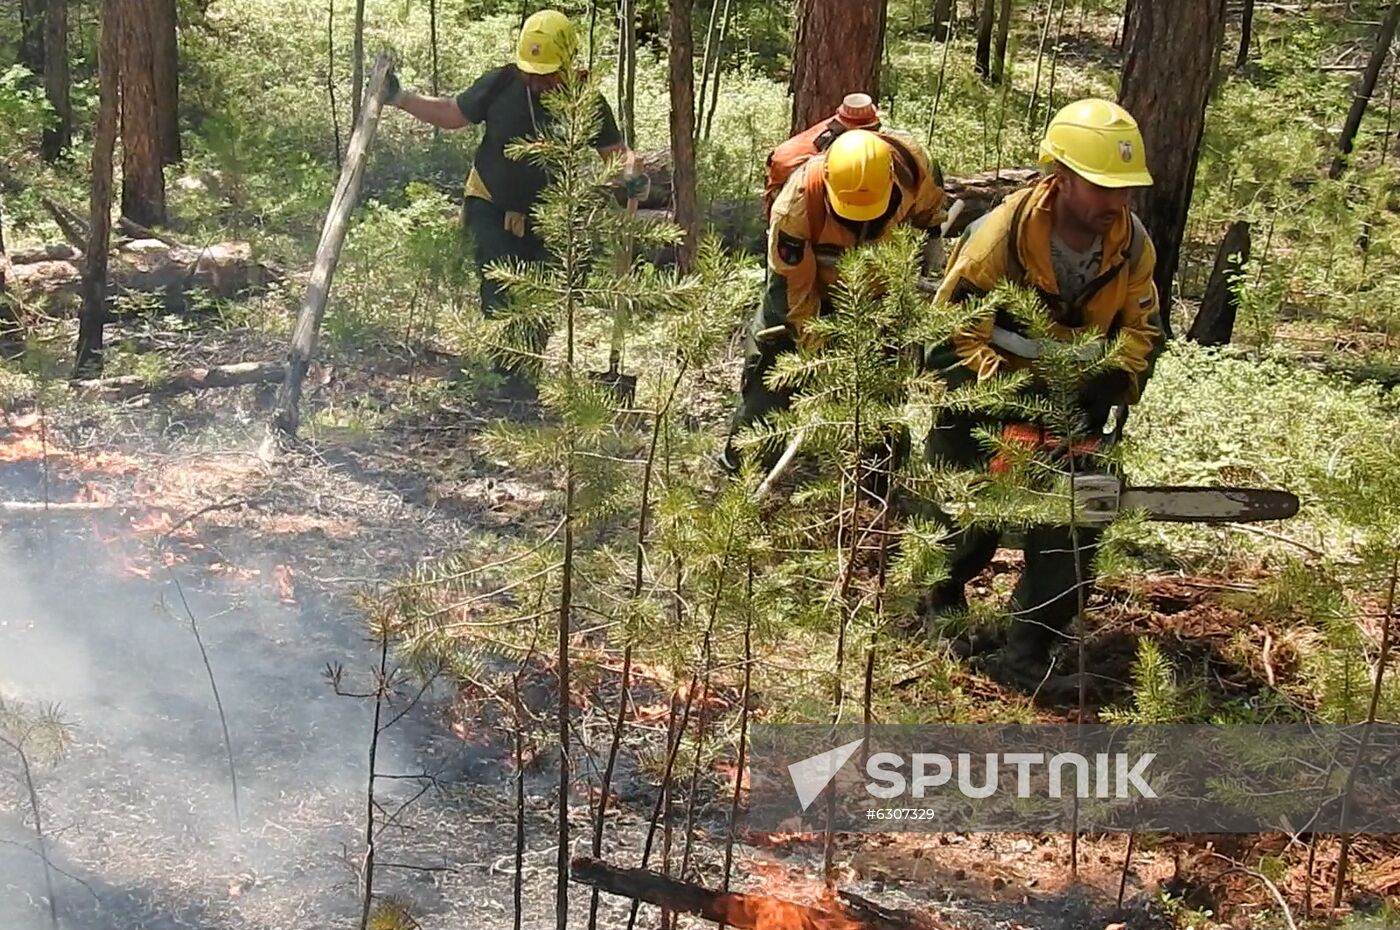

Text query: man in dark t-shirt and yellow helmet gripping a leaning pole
(388, 10), (648, 388)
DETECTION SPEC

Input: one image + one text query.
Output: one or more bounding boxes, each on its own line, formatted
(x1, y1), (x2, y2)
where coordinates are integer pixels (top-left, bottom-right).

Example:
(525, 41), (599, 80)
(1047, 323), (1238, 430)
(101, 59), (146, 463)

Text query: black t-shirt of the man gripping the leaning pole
(456, 64), (622, 213)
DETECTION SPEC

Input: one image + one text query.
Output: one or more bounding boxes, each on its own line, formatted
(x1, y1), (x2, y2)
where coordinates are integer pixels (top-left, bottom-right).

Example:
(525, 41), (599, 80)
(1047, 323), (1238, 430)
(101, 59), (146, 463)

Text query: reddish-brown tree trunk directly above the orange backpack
(792, 0), (886, 133)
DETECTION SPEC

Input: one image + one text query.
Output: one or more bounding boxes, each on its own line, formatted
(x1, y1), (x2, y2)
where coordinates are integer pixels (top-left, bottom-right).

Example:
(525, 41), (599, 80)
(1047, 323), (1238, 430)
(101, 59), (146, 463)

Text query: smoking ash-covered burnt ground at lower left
(0, 380), (1181, 930)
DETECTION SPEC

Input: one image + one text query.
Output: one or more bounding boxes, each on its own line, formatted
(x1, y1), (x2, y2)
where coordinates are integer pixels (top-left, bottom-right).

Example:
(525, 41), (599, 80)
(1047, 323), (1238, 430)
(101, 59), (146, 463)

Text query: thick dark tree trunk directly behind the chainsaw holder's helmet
(1119, 0), (1225, 338)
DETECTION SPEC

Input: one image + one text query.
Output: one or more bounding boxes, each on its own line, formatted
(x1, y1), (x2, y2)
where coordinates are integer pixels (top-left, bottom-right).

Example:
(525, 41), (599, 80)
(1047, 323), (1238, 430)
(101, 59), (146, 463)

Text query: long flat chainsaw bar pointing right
(1075, 475), (1299, 524)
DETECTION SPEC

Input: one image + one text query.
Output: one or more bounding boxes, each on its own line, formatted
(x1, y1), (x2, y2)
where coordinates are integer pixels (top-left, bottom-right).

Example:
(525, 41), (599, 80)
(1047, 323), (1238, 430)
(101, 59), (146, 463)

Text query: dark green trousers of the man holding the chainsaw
(924, 415), (1102, 654)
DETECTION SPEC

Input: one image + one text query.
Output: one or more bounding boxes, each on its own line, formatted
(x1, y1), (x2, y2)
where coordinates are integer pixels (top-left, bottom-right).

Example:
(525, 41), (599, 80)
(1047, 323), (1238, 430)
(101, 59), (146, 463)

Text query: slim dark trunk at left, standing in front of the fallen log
(73, 0), (121, 377)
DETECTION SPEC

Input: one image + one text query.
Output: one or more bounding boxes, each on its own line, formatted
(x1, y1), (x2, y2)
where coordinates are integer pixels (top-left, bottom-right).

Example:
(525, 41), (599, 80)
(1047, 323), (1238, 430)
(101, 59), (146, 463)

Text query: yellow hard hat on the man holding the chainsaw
(1040, 97), (1152, 188)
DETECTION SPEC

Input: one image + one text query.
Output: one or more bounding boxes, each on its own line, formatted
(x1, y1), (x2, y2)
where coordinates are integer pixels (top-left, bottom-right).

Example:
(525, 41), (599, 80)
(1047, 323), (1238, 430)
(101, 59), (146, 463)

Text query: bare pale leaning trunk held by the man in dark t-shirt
(265, 55), (389, 448)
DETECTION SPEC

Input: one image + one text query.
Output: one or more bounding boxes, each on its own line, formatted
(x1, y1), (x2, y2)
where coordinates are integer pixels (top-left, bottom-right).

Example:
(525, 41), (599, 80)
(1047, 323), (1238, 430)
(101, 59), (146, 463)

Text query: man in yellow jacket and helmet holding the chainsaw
(925, 99), (1162, 668)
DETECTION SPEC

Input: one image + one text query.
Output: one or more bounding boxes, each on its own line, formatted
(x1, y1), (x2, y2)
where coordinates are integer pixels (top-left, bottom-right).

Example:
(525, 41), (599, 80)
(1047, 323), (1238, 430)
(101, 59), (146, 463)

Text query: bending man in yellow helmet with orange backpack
(720, 129), (945, 472)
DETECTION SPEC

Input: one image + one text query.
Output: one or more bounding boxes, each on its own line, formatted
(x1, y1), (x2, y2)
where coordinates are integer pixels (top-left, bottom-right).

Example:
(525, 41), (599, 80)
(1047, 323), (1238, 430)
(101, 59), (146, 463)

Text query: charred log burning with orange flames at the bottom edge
(570, 857), (939, 930)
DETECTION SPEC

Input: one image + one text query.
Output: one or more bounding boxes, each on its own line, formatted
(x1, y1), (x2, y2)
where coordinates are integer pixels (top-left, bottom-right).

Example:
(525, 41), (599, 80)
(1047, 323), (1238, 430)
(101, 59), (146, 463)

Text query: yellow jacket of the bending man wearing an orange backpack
(769, 133), (946, 340)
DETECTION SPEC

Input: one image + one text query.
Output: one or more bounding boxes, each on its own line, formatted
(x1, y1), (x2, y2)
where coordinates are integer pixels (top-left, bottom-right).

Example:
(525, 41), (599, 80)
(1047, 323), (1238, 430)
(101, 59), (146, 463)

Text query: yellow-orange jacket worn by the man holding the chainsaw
(937, 176), (1162, 403)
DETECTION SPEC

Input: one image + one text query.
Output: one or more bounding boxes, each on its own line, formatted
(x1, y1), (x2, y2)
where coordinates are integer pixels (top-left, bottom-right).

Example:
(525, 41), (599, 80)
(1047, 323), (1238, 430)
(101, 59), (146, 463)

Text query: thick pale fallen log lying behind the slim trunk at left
(10, 240), (276, 314)
